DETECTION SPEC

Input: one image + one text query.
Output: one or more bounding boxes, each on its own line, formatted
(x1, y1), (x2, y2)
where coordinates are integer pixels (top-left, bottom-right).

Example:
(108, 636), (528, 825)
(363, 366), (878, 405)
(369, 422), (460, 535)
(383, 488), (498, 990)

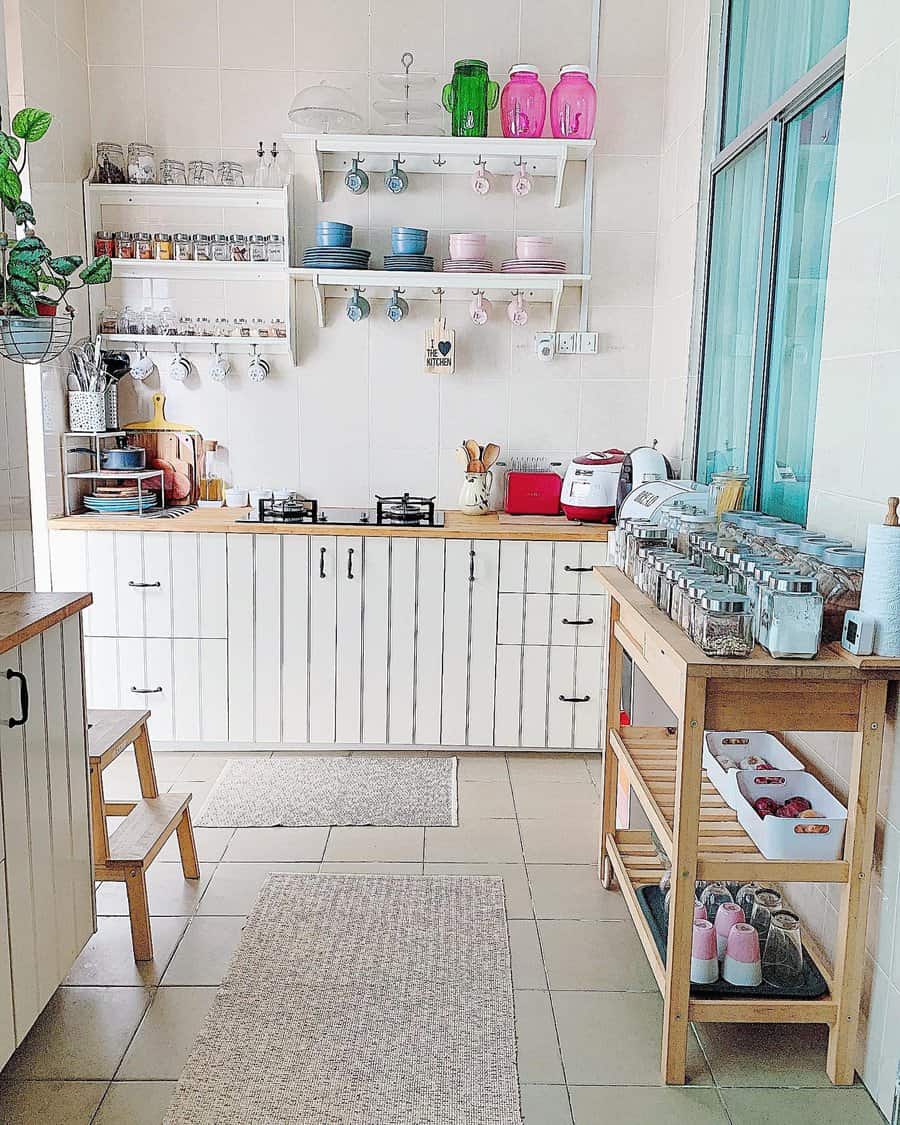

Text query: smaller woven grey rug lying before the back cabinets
(195, 756), (458, 828)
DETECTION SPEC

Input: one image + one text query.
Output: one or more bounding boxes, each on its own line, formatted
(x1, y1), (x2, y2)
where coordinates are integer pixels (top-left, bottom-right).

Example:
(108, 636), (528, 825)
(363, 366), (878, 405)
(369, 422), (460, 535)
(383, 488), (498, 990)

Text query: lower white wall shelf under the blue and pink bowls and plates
(290, 269), (591, 332)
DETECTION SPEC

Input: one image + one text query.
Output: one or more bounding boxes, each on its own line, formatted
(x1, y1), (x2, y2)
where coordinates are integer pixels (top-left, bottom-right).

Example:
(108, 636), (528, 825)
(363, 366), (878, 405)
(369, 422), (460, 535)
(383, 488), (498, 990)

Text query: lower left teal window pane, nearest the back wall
(696, 138), (766, 482)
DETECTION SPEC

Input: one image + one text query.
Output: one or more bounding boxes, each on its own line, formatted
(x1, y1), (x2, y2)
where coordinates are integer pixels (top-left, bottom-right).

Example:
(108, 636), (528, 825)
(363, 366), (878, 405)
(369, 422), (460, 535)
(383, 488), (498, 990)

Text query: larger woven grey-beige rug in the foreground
(164, 874), (522, 1125)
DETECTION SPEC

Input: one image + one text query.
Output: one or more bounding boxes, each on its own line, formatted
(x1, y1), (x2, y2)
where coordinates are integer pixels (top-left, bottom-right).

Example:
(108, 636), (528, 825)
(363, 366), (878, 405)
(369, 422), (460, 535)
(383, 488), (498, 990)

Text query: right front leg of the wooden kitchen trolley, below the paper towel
(826, 680), (888, 1086)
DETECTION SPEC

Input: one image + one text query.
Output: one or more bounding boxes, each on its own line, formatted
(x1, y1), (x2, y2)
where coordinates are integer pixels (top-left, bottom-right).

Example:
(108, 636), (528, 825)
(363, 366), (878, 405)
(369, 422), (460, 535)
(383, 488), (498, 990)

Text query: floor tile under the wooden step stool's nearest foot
(63, 917), (188, 986)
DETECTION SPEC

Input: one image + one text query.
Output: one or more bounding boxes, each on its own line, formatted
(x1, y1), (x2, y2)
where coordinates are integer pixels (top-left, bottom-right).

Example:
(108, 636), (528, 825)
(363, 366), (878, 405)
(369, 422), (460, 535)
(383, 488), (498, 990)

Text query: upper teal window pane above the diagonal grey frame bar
(722, 0), (849, 146)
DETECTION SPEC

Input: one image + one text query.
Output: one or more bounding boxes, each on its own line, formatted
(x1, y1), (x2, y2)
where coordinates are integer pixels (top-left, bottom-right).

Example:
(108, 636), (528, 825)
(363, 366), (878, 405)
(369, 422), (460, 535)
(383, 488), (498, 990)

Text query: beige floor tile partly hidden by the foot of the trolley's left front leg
(552, 992), (712, 1086)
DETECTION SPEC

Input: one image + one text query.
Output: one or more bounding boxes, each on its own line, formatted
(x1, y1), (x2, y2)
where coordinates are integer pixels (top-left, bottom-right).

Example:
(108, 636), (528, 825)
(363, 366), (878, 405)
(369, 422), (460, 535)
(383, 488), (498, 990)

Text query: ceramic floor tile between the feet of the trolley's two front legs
(698, 1024), (831, 1087)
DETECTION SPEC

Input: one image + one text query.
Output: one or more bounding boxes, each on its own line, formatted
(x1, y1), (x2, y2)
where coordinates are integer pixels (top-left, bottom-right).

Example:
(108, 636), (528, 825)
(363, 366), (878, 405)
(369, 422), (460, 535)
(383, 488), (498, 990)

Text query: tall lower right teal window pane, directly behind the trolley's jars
(761, 83), (842, 523)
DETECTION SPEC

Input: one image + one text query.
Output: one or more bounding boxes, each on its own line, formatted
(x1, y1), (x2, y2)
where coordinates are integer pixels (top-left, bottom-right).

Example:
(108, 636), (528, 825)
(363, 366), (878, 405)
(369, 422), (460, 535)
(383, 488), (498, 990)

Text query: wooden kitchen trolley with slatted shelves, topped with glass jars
(595, 566), (900, 1086)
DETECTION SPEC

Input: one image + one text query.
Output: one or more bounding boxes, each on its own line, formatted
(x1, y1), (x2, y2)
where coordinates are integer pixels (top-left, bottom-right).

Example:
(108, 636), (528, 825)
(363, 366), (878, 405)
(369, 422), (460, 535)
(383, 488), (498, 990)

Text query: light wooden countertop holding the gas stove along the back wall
(50, 507), (611, 542)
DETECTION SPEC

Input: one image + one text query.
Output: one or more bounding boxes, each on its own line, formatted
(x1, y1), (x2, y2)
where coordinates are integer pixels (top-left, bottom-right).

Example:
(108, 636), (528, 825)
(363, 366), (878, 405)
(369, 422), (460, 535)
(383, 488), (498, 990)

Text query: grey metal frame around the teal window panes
(690, 0), (847, 507)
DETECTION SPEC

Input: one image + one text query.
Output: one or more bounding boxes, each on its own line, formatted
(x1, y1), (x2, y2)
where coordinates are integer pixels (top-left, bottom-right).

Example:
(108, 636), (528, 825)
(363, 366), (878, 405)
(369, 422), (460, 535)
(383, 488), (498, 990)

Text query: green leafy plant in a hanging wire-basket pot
(0, 108), (113, 363)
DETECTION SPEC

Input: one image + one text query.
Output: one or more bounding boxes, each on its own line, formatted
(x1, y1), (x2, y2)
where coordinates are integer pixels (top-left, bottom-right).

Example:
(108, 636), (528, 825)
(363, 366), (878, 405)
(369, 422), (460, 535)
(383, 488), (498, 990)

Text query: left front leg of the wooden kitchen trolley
(662, 678), (707, 1086)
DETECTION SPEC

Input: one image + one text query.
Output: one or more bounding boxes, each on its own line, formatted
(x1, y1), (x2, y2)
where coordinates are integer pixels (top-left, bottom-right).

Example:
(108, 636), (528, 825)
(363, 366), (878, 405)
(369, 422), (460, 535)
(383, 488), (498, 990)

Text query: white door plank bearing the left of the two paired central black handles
(309, 536), (338, 743)
